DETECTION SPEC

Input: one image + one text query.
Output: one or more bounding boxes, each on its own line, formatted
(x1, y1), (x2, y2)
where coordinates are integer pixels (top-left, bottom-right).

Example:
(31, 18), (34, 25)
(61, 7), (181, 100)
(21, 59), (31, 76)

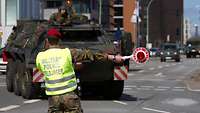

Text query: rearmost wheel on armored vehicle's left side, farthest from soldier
(6, 59), (17, 92)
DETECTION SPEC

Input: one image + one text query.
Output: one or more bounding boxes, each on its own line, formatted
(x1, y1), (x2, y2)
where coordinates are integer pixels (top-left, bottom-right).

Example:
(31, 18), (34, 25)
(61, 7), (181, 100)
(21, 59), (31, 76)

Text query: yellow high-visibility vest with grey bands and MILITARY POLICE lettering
(36, 48), (77, 95)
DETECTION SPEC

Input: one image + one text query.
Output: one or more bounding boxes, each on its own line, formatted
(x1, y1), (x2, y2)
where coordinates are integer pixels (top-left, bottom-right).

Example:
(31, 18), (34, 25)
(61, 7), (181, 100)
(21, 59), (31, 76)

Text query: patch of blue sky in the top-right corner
(184, 0), (200, 25)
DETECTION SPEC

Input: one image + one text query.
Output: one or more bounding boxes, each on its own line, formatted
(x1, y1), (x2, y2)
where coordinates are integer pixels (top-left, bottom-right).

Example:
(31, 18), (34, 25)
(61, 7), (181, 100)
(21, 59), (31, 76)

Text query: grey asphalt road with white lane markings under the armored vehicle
(0, 58), (200, 113)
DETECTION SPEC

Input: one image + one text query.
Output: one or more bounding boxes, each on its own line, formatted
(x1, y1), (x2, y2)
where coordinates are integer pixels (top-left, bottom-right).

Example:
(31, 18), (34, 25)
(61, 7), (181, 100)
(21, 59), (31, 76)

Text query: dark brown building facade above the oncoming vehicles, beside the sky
(140, 0), (184, 47)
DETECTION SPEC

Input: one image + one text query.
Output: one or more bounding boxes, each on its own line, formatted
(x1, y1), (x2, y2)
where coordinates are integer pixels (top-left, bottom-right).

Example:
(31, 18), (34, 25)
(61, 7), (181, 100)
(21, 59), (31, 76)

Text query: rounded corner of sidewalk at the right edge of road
(185, 70), (200, 92)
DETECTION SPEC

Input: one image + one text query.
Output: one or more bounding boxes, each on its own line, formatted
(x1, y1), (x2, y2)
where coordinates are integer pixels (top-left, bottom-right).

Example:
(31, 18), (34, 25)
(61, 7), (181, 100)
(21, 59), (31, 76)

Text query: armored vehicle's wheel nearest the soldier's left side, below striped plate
(22, 70), (40, 99)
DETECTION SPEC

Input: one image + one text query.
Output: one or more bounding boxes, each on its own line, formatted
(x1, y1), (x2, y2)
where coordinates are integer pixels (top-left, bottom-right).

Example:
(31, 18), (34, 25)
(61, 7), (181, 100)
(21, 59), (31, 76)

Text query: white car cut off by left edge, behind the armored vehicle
(0, 48), (7, 73)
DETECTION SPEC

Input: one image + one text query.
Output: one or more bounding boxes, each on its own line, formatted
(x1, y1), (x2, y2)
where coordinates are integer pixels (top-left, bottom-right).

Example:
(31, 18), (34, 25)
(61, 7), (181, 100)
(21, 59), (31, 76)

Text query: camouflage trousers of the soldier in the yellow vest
(48, 92), (83, 113)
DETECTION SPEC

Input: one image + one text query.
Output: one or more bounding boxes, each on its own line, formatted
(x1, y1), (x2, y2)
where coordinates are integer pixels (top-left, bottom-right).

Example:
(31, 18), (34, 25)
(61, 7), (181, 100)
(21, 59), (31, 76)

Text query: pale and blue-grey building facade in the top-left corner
(0, 0), (43, 47)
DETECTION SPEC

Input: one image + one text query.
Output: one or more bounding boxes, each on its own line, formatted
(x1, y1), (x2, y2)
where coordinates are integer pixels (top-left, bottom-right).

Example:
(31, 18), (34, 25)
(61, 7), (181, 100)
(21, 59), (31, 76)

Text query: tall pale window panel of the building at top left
(6, 0), (18, 25)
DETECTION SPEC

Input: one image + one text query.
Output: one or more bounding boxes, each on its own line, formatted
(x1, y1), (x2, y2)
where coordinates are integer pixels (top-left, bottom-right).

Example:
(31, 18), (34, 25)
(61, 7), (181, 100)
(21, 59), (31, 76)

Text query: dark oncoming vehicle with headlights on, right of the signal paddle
(160, 43), (180, 62)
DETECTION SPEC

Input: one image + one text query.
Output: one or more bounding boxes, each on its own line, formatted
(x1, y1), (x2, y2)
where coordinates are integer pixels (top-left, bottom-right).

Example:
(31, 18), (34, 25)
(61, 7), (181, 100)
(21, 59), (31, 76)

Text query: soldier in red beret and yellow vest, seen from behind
(36, 29), (122, 113)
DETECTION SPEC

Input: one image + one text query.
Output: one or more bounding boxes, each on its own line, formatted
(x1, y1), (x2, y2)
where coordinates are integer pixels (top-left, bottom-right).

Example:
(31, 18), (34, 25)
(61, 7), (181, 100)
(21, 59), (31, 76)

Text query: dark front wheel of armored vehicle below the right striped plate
(103, 80), (124, 100)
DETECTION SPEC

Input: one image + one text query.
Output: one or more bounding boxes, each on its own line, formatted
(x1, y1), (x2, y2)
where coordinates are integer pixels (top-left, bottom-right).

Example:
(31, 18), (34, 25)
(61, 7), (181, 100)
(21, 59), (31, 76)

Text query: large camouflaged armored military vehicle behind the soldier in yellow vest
(5, 16), (132, 99)
